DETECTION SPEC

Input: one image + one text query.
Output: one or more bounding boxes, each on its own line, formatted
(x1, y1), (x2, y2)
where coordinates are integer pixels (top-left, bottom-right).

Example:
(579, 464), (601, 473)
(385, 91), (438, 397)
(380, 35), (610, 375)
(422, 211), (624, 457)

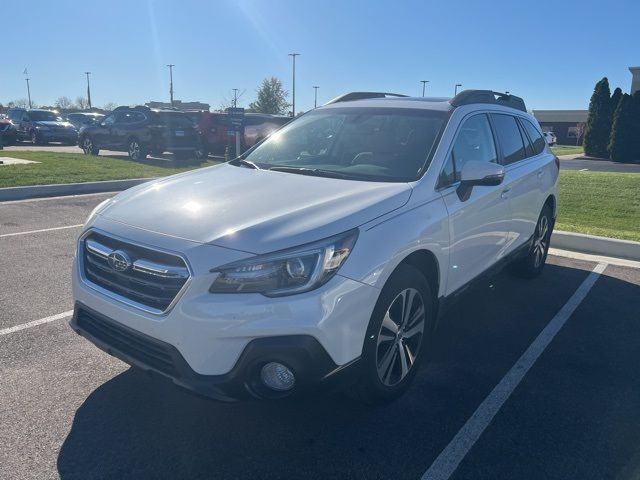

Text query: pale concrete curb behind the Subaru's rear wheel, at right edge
(551, 230), (640, 261)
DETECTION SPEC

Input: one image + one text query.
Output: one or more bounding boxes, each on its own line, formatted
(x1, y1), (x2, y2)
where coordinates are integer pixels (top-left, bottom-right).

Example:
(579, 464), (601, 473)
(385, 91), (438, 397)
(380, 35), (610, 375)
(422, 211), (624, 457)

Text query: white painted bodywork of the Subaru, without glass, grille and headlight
(73, 100), (557, 375)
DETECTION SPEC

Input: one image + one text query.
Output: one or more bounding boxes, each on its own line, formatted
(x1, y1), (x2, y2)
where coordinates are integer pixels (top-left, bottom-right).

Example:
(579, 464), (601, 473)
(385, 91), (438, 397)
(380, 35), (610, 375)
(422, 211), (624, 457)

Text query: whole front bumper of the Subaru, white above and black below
(72, 219), (379, 399)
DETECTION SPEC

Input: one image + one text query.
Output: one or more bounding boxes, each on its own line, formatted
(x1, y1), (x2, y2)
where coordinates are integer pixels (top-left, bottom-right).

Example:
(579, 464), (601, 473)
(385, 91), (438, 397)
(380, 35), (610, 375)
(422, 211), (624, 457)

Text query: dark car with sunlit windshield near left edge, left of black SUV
(7, 108), (78, 145)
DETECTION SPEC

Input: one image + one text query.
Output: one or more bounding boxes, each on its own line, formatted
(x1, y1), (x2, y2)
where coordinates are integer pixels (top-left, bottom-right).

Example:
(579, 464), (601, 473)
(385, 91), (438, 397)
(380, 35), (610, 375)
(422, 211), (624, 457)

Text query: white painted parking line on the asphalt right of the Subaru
(422, 263), (607, 480)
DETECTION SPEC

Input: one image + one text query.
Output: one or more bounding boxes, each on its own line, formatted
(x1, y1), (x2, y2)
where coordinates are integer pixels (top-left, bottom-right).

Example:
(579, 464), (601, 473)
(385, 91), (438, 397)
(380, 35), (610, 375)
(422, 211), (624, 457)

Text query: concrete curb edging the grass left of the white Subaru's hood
(0, 178), (154, 202)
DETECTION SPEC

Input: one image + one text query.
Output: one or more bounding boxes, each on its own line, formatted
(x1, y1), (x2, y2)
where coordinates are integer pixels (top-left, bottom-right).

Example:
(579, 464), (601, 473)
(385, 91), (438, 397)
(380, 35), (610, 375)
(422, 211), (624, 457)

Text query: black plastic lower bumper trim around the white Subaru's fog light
(69, 303), (359, 402)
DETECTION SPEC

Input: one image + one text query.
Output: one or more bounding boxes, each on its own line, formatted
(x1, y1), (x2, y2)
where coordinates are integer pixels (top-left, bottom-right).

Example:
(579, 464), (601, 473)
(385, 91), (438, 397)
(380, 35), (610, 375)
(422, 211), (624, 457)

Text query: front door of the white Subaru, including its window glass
(438, 113), (511, 294)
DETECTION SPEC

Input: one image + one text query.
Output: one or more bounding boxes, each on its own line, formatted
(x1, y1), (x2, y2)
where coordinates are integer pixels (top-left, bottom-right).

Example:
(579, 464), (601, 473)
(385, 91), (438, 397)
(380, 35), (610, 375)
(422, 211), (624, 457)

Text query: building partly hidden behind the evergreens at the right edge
(532, 67), (640, 145)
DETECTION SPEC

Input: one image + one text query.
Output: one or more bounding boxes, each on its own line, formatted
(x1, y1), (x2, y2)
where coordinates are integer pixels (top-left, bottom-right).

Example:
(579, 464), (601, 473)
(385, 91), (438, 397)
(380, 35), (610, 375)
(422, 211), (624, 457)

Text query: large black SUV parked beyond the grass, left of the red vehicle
(78, 106), (199, 160)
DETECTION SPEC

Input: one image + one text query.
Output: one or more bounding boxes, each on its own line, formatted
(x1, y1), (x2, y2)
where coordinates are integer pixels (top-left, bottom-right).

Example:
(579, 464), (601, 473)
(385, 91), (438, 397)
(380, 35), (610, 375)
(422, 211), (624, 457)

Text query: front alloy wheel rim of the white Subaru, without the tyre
(376, 288), (426, 386)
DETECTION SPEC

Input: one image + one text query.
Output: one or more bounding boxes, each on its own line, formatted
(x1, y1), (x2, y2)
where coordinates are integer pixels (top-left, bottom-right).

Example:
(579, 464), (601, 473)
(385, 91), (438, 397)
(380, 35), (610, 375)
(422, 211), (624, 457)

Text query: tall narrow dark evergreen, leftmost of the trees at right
(584, 77), (612, 157)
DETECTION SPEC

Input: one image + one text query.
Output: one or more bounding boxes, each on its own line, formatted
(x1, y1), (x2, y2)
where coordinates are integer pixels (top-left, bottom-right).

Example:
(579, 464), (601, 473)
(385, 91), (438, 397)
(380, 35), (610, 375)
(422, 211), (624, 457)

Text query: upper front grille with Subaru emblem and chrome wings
(81, 231), (189, 313)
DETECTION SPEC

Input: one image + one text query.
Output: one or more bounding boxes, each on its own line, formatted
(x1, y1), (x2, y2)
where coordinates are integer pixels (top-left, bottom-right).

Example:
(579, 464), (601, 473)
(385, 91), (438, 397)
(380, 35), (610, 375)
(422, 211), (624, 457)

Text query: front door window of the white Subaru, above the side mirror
(439, 115), (498, 186)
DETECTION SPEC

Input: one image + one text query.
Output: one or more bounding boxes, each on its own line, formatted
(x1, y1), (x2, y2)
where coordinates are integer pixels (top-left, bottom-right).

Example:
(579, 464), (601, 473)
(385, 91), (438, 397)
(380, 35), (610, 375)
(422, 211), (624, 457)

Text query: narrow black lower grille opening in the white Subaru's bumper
(76, 308), (178, 377)
